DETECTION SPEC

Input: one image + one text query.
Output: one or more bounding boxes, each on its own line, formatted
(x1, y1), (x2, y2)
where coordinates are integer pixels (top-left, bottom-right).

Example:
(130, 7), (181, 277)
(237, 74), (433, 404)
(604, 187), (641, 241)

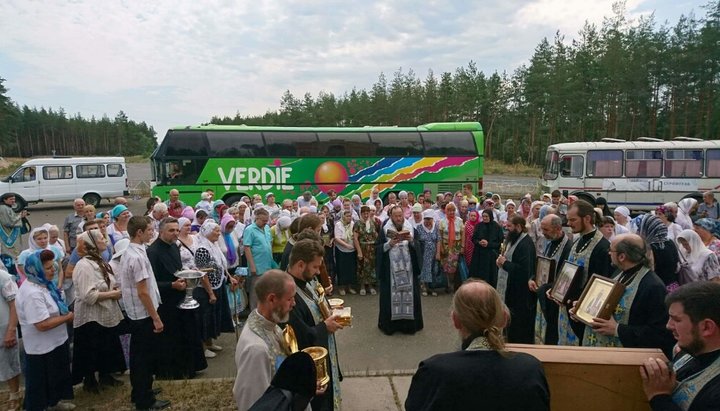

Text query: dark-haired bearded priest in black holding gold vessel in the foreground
(288, 238), (343, 411)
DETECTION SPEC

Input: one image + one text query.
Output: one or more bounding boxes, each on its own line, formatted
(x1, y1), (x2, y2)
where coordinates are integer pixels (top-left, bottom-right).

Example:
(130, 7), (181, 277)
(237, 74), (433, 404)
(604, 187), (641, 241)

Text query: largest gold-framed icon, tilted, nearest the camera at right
(575, 274), (625, 325)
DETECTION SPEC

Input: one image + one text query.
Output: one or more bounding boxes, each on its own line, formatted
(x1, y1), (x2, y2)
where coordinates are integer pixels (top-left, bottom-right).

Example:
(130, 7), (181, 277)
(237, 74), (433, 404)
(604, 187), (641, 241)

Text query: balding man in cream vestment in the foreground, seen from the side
(233, 270), (295, 410)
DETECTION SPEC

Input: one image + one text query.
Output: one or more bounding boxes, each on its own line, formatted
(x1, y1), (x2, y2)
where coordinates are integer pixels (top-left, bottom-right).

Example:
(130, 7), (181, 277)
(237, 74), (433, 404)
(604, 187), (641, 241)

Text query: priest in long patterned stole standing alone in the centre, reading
(375, 206), (423, 335)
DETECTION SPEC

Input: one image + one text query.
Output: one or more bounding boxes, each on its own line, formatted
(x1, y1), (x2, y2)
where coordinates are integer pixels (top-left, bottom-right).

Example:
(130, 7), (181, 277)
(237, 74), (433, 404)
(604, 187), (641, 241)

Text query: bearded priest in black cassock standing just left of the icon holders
(496, 215), (537, 344)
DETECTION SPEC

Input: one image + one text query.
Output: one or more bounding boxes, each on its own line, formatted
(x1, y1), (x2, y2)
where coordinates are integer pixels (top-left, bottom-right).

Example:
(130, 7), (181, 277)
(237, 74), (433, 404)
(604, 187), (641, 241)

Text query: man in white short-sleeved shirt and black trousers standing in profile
(118, 216), (170, 410)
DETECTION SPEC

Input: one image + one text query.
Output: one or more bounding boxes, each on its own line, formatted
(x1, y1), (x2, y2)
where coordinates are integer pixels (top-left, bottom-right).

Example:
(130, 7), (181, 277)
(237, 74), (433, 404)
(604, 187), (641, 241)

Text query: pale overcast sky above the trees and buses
(0, 0), (705, 142)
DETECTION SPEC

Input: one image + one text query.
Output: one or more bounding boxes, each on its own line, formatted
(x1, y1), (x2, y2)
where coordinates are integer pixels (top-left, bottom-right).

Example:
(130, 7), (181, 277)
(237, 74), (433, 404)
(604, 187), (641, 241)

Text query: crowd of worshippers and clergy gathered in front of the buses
(0, 185), (720, 410)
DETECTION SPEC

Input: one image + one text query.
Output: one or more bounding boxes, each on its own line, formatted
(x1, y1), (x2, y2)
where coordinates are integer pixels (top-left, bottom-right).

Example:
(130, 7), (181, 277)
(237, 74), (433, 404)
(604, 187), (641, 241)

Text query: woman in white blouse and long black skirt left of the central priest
(335, 209), (357, 295)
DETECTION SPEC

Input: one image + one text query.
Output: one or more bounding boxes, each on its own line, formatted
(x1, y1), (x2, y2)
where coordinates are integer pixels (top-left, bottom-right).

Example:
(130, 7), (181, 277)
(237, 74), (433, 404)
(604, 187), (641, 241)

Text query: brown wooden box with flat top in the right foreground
(507, 344), (667, 411)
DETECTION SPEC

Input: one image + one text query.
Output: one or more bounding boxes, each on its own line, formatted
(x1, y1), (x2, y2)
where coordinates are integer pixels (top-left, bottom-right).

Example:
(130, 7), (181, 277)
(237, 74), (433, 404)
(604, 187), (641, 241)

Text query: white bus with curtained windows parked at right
(541, 137), (720, 210)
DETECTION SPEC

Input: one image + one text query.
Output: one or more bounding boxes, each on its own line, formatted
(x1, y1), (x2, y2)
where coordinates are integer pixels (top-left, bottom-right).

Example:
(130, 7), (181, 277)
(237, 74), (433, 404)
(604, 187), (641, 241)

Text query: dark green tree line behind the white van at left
(0, 78), (157, 157)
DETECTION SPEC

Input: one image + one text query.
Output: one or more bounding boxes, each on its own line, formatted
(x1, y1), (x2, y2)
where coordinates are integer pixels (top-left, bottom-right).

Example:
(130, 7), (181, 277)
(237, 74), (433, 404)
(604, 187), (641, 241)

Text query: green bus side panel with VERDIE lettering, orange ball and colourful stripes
(197, 157), (480, 198)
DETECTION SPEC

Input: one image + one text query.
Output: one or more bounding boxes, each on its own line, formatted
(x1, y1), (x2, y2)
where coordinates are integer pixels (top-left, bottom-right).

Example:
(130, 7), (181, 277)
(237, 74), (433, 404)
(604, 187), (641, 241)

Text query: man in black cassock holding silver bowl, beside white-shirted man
(147, 217), (207, 379)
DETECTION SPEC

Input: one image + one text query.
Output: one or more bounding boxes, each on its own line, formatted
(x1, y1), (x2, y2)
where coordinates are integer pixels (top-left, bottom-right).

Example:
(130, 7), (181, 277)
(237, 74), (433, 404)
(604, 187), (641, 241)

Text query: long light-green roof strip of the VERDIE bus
(171, 121), (482, 132)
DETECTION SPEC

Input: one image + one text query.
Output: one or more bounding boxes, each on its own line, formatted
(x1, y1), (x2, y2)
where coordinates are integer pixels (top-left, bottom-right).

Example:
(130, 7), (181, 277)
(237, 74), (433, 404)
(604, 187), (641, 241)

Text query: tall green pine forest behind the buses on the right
(211, 0), (720, 164)
